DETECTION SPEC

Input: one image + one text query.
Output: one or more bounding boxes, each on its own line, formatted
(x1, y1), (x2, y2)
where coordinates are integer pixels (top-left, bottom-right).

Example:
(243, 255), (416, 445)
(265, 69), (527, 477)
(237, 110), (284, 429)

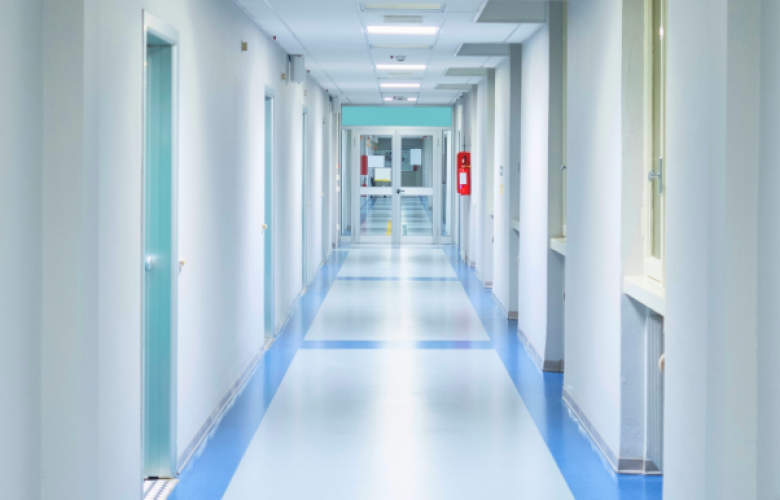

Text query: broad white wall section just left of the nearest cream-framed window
(564, 0), (622, 454)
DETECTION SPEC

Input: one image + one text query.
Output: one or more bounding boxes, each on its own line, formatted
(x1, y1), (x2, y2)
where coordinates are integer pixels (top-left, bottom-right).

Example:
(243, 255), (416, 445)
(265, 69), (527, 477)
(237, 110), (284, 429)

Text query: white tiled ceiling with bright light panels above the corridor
(234, 0), (541, 105)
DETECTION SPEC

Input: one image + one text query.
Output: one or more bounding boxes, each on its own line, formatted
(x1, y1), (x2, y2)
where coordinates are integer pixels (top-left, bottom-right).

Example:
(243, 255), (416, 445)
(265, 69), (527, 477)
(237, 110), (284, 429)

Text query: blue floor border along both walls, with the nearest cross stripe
(169, 247), (663, 500)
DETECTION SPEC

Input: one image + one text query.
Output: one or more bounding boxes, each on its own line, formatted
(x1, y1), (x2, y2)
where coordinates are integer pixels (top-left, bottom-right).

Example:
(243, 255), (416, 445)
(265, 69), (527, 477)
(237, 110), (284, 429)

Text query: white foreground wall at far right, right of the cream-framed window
(664, 0), (760, 500)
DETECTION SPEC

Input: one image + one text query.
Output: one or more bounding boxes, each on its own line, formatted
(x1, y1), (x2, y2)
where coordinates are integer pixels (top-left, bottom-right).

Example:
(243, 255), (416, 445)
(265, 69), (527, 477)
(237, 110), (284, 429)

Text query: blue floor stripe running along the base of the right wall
(444, 247), (663, 500)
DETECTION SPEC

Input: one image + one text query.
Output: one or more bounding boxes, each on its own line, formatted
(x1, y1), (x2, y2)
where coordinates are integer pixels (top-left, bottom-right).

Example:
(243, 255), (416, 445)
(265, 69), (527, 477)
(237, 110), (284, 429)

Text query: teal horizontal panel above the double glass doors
(341, 106), (452, 127)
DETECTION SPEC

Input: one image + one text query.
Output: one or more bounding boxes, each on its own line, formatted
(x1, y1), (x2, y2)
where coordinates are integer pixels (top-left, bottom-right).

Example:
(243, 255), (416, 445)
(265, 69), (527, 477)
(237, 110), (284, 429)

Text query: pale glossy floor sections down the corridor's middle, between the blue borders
(219, 248), (573, 500)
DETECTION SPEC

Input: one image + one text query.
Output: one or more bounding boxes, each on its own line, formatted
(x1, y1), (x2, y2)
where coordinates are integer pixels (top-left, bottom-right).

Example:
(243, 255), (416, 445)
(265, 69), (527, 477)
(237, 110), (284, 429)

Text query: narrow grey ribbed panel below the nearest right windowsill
(645, 313), (664, 474)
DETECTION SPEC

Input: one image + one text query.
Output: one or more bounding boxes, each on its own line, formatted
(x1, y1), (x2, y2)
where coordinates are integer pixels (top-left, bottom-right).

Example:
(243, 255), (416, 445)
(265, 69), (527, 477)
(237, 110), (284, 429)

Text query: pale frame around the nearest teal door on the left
(140, 10), (181, 478)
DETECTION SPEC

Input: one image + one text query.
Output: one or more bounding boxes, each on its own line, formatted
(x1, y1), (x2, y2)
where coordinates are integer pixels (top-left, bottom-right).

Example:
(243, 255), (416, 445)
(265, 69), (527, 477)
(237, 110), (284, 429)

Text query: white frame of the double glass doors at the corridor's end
(339, 126), (448, 245)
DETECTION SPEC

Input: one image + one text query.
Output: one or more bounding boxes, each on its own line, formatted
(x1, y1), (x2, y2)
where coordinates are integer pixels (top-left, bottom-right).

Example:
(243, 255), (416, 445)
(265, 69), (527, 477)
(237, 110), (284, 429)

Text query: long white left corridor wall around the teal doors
(16, 0), (330, 500)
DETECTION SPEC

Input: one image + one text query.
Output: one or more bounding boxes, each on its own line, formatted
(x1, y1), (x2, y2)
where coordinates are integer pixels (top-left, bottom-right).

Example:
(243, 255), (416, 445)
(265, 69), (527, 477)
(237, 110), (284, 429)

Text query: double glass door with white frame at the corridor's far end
(349, 129), (450, 244)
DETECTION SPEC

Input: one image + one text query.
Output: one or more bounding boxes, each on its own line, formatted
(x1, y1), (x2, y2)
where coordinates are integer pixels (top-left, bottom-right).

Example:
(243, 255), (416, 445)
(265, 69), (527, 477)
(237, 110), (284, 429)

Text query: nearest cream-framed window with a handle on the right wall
(645, 0), (666, 283)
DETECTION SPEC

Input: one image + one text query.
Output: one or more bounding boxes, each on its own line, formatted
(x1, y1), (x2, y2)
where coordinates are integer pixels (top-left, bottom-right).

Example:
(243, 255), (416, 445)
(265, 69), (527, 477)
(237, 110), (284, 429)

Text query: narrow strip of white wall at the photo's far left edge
(0, 0), (43, 500)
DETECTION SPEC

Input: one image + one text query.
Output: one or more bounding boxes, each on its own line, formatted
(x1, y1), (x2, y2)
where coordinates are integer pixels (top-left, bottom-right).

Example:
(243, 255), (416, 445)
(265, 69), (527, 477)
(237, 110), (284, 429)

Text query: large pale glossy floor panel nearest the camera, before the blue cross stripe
(224, 349), (573, 500)
